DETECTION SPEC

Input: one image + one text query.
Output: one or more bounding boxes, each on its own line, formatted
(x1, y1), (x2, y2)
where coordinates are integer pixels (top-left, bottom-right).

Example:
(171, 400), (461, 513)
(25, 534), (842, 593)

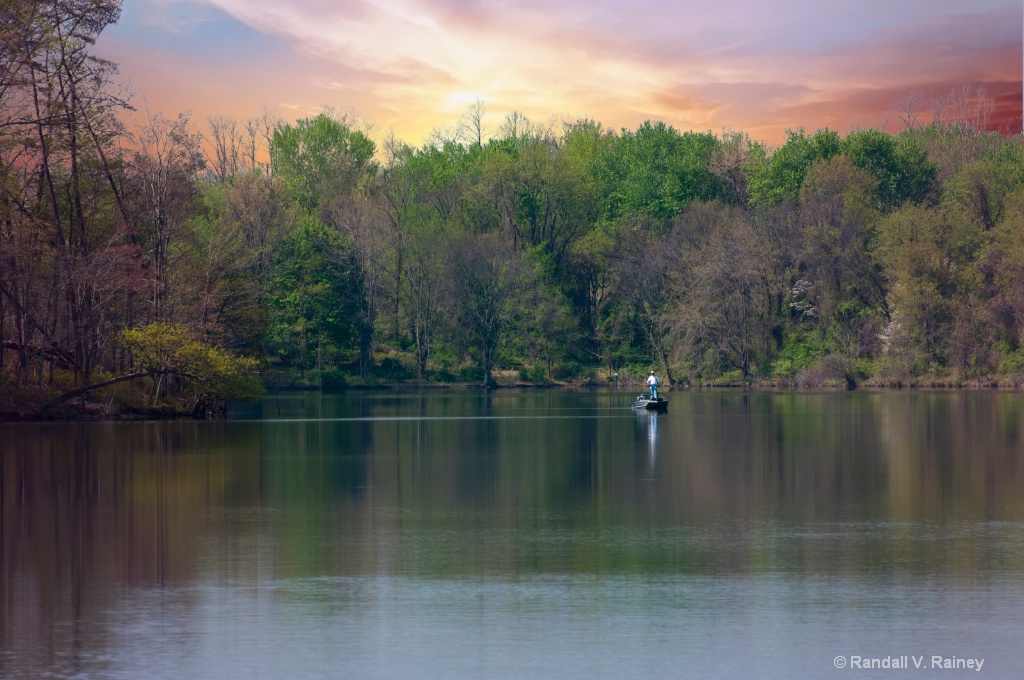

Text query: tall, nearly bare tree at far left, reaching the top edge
(0, 0), (138, 382)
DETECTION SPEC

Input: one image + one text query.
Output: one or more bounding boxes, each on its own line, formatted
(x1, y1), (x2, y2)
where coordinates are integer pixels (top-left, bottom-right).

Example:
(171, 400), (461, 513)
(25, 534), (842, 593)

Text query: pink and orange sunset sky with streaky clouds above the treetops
(97, 0), (1024, 144)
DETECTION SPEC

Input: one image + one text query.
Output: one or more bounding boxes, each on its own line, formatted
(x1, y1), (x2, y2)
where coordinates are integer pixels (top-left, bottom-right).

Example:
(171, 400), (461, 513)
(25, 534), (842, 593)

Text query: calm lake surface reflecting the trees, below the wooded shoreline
(0, 390), (1024, 680)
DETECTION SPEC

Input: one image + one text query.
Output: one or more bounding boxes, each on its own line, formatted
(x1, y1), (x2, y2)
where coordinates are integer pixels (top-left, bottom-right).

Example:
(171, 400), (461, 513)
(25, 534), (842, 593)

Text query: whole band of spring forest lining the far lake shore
(0, 0), (1024, 411)
